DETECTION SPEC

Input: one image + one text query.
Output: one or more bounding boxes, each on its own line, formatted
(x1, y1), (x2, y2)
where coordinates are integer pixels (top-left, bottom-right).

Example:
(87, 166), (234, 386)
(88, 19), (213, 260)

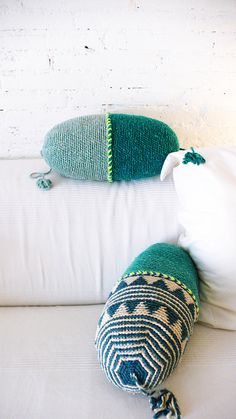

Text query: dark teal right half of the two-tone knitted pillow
(110, 114), (179, 180)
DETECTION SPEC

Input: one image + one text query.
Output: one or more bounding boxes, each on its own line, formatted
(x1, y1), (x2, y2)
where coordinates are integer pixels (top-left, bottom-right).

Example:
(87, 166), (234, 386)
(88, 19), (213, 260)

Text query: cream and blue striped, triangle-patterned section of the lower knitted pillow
(95, 272), (199, 393)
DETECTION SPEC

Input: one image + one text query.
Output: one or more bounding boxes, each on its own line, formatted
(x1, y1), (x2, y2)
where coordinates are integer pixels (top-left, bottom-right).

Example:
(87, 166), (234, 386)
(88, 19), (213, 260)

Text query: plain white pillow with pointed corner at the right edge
(161, 148), (236, 330)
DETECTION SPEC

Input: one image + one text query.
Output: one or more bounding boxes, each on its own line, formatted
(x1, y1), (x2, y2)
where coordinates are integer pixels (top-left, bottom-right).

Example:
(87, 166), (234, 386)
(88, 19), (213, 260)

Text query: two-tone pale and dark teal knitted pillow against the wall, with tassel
(32, 114), (179, 189)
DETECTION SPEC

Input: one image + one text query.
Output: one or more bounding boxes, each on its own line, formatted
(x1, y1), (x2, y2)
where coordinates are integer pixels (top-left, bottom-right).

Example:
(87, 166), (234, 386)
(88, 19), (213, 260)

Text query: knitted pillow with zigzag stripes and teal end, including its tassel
(95, 243), (199, 418)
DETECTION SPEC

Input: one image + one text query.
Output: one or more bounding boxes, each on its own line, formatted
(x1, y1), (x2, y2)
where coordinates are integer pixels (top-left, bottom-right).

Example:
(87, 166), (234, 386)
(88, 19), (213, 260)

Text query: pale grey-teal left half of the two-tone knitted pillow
(41, 115), (107, 180)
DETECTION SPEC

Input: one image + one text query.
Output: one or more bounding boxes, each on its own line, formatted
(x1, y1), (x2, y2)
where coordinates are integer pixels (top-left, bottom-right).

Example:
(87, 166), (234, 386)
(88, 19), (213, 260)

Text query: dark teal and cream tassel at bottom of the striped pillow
(150, 389), (181, 419)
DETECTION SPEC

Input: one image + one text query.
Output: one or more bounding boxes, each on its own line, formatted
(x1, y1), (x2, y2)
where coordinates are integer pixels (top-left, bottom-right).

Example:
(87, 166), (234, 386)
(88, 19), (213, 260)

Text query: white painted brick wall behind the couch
(0, 0), (236, 157)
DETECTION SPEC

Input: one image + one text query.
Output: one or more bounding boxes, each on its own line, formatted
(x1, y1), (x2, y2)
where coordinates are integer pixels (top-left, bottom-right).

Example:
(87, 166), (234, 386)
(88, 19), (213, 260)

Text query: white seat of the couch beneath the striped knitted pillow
(0, 305), (236, 419)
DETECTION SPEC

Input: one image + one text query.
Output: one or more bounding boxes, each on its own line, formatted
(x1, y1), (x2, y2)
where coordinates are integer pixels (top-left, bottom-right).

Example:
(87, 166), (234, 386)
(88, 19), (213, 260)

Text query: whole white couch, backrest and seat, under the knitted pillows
(0, 159), (236, 419)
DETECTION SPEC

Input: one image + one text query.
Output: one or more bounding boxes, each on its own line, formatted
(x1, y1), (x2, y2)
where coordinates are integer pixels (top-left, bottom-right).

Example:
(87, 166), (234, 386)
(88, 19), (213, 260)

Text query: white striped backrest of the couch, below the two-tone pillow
(0, 159), (179, 305)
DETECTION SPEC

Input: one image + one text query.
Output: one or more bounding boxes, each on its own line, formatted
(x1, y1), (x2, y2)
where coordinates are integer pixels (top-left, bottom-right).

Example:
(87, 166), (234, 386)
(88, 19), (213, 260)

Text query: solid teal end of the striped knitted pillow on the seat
(123, 243), (200, 306)
